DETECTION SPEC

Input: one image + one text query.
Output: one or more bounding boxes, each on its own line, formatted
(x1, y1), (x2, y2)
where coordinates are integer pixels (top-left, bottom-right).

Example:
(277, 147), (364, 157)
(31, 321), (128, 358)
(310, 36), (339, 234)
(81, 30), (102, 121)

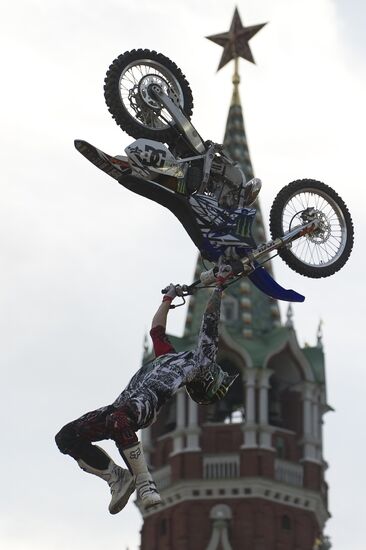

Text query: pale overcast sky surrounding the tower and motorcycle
(0, 0), (366, 550)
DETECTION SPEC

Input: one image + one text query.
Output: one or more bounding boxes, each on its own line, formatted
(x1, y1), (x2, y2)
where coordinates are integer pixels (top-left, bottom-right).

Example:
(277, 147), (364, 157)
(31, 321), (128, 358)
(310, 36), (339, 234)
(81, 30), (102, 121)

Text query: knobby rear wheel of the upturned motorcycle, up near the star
(104, 49), (193, 144)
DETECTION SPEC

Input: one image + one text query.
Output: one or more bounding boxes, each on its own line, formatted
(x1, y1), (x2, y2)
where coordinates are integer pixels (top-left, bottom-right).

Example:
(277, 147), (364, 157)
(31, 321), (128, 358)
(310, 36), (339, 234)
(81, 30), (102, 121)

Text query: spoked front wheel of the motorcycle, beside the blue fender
(270, 179), (353, 278)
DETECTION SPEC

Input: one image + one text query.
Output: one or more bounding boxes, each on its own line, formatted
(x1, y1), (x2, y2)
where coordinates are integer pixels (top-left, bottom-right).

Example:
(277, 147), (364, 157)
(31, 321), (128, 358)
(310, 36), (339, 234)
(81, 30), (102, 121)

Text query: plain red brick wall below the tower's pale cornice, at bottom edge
(141, 498), (318, 550)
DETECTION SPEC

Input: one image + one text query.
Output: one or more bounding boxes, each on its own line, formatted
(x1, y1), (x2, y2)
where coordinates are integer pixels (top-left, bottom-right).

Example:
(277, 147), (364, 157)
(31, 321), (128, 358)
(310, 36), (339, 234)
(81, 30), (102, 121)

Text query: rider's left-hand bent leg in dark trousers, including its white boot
(55, 407), (135, 514)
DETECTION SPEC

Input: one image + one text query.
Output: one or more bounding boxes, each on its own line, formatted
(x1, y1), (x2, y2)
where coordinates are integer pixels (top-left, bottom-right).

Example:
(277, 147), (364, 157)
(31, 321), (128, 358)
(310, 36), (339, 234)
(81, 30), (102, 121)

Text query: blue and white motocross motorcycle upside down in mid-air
(75, 49), (353, 302)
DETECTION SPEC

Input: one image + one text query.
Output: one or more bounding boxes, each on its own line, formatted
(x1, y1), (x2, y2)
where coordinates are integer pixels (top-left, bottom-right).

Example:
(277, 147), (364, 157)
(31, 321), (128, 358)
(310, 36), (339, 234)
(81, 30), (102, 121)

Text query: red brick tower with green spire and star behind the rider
(141, 10), (330, 550)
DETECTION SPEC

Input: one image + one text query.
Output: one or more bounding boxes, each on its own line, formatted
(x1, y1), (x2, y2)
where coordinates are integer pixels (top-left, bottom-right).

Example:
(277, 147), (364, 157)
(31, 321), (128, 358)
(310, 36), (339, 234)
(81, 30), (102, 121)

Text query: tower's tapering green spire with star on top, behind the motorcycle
(185, 8), (281, 342)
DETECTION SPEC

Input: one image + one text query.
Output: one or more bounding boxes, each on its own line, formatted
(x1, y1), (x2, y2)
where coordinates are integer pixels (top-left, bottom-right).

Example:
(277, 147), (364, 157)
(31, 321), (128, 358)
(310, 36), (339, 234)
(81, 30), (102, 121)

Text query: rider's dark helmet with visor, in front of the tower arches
(186, 363), (239, 405)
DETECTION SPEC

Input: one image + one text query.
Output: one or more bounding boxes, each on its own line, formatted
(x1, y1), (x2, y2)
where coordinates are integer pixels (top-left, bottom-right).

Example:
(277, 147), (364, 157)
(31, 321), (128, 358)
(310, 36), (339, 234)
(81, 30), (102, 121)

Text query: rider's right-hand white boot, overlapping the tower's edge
(122, 441), (161, 509)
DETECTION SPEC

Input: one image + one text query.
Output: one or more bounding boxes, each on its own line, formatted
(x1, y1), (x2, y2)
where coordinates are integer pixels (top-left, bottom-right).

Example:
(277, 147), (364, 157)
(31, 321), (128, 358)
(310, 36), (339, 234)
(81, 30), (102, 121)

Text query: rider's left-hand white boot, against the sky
(77, 447), (135, 514)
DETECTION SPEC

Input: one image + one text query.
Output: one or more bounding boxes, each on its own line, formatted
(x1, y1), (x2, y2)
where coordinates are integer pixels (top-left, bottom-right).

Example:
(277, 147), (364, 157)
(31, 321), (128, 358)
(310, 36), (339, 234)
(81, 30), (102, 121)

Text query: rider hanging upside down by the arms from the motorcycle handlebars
(56, 264), (236, 514)
